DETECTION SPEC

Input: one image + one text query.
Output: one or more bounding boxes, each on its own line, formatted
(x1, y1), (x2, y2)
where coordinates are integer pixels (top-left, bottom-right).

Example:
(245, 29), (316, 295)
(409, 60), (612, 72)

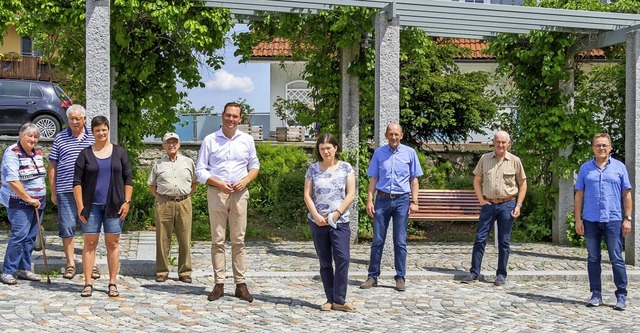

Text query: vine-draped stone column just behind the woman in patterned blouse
(340, 44), (360, 244)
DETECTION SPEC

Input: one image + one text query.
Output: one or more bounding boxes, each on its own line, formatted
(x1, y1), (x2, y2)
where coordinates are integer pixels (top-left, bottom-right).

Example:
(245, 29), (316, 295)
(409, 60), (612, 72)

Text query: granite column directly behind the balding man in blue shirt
(374, 12), (400, 264)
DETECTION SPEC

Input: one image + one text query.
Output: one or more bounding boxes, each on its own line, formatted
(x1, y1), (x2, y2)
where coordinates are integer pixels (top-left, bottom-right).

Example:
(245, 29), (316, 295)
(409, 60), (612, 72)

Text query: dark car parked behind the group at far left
(0, 79), (71, 138)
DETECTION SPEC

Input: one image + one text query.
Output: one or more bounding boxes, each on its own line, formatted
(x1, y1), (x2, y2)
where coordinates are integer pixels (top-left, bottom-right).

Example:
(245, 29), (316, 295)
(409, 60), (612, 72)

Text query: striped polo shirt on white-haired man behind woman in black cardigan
(49, 127), (96, 193)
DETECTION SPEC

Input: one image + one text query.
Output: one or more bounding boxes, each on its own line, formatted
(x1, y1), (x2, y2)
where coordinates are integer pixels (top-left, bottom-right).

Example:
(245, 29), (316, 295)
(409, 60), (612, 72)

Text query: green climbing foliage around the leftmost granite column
(8, 0), (231, 155)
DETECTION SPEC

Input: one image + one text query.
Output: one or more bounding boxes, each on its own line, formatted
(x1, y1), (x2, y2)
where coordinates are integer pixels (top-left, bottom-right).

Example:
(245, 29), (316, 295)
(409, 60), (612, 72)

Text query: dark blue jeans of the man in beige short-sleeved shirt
(471, 199), (516, 277)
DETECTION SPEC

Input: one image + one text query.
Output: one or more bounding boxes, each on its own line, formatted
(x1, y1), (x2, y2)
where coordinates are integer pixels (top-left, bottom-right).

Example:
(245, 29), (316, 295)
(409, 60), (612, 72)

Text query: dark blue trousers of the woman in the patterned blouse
(309, 221), (351, 305)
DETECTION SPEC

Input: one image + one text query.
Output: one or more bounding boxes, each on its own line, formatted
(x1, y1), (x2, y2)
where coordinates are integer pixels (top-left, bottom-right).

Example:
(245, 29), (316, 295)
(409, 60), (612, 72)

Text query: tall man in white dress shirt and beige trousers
(196, 102), (260, 302)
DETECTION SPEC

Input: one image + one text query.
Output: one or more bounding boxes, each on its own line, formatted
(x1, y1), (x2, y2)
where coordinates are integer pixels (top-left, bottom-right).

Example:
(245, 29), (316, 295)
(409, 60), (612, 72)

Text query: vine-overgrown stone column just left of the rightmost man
(551, 67), (575, 245)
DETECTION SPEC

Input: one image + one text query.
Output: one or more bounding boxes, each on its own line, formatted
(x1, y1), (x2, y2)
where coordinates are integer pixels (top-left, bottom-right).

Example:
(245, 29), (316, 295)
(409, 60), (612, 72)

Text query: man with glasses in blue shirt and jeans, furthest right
(574, 133), (633, 310)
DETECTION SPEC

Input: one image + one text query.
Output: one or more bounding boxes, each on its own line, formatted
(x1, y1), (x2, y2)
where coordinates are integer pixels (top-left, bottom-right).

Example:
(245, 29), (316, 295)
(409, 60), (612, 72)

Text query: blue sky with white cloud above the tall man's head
(182, 24), (270, 114)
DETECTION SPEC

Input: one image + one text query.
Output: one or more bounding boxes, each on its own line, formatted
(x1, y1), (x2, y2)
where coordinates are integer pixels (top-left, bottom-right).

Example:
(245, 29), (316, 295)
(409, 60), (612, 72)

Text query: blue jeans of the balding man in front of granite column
(368, 193), (410, 281)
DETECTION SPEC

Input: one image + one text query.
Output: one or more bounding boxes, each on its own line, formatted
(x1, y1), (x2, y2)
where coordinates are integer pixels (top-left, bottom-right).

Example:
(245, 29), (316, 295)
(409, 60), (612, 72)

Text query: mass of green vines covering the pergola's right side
(489, 0), (640, 240)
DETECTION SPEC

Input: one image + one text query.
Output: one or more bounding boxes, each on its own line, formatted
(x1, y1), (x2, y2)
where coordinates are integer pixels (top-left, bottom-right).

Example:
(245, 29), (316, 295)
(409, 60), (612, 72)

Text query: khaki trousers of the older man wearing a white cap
(154, 196), (193, 276)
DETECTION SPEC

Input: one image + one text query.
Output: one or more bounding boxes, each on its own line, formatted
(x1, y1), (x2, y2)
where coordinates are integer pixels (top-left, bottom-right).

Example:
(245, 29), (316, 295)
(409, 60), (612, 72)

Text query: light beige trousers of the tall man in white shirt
(207, 186), (249, 284)
